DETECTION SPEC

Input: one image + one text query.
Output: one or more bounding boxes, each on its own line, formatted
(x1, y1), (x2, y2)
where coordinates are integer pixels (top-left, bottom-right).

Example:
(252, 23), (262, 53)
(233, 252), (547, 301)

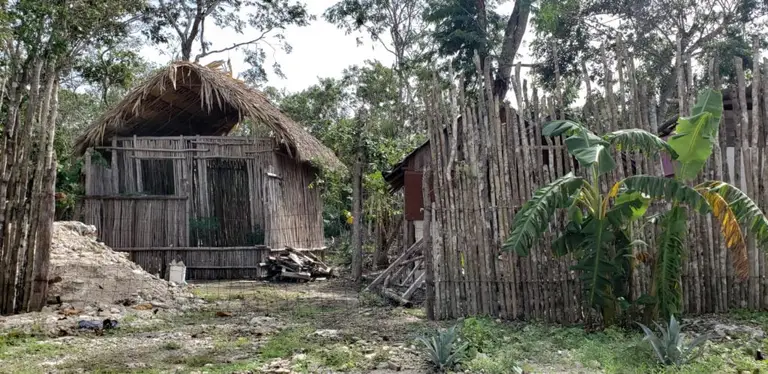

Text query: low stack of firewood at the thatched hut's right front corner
(261, 247), (335, 282)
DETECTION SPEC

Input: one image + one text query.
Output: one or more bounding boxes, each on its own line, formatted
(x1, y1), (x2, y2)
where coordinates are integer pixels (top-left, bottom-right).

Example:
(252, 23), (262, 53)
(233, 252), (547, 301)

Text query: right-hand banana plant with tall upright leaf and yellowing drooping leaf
(610, 90), (768, 320)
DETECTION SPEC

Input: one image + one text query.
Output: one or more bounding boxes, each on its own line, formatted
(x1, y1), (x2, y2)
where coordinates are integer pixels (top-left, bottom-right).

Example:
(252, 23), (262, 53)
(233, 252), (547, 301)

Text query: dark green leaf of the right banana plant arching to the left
(619, 175), (709, 214)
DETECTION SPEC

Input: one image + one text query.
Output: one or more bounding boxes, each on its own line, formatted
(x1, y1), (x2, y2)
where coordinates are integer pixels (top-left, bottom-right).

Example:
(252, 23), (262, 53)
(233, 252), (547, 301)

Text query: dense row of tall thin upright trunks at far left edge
(0, 57), (59, 314)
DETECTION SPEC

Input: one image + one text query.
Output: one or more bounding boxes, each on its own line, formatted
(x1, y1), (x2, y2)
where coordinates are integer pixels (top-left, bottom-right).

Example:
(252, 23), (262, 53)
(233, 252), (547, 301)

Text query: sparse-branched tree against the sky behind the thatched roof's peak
(143, 0), (314, 83)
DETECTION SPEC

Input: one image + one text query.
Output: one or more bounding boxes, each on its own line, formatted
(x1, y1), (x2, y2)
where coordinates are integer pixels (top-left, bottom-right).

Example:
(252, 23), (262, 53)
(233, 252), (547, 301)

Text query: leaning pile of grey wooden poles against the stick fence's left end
(365, 240), (426, 307)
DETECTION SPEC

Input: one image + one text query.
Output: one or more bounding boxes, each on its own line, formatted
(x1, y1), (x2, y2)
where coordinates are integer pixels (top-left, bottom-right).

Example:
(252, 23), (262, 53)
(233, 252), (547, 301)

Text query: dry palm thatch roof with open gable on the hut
(75, 61), (344, 168)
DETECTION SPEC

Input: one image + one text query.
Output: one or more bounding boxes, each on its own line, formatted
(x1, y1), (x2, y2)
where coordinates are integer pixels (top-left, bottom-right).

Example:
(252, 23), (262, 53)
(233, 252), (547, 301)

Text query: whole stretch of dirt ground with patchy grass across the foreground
(0, 280), (768, 374)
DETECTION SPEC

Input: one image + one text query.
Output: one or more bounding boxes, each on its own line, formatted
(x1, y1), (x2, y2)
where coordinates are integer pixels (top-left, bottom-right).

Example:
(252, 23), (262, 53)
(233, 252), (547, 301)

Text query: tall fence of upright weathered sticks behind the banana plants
(423, 39), (768, 323)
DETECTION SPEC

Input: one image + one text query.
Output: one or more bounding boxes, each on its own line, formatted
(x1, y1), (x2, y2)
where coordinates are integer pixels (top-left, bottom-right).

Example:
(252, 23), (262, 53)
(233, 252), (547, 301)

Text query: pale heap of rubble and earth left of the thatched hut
(0, 222), (202, 335)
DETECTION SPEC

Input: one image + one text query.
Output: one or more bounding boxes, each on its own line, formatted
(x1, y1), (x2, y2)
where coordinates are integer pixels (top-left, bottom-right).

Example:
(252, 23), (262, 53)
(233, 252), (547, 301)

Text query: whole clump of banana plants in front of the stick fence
(503, 90), (768, 324)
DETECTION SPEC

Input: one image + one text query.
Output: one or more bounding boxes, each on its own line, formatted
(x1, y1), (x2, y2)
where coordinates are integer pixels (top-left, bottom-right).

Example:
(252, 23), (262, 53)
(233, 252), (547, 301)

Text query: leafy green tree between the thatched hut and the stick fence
(276, 61), (423, 272)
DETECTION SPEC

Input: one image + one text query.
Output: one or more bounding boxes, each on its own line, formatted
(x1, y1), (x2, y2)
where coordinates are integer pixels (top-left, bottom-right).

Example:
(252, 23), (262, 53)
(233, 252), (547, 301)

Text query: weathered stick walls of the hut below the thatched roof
(82, 136), (325, 279)
